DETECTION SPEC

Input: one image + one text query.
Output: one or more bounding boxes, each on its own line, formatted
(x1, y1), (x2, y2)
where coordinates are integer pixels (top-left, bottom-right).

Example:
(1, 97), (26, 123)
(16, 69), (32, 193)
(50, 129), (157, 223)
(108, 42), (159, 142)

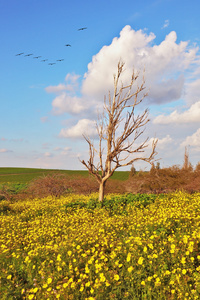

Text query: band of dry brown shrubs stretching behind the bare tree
(0, 159), (200, 201)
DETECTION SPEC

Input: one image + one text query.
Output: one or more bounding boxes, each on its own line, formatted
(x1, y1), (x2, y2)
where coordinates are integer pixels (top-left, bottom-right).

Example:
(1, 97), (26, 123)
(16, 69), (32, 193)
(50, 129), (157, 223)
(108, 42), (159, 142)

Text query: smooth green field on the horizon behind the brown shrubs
(0, 168), (129, 183)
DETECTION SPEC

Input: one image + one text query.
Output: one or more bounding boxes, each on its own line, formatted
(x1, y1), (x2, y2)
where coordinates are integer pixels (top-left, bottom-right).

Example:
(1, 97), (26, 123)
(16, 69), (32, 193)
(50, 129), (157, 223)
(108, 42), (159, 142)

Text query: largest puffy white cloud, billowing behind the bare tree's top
(82, 25), (198, 103)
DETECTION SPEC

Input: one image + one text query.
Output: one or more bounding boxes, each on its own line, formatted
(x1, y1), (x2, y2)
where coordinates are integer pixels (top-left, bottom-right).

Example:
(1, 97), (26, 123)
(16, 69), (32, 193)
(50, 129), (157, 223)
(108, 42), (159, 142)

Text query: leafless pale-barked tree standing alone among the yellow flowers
(81, 62), (157, 201)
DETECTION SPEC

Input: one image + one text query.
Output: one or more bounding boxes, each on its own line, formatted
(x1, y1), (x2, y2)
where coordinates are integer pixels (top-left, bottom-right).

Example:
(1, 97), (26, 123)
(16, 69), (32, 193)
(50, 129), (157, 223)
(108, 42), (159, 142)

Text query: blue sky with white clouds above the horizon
(0, 0), (200, 169)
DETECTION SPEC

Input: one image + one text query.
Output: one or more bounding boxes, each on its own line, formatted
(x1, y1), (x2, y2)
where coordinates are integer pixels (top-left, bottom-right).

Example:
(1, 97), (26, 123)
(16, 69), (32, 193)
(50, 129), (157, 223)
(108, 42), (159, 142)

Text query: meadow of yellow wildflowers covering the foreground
(0, 192), (200, 300)
